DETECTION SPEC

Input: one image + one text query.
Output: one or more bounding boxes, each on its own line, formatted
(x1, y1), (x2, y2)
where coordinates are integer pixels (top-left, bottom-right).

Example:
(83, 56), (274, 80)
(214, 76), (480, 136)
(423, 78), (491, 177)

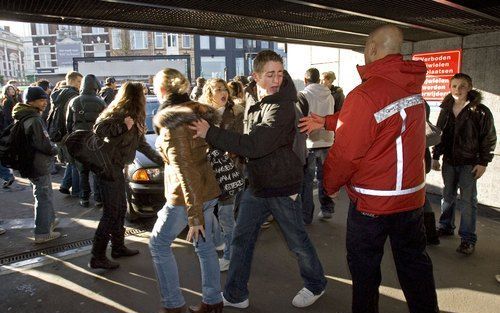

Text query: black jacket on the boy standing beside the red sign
(432, 90), (497, 166)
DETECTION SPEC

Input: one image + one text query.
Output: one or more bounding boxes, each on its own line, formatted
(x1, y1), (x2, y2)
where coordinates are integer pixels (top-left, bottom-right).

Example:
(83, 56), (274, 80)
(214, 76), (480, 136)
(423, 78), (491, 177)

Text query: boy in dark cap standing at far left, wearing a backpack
(13, 87), (61, 243)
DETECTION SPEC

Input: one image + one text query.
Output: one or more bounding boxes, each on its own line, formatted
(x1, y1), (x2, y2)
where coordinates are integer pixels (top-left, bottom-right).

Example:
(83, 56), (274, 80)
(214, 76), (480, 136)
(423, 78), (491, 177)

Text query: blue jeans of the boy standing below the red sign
(439, 162), (477, 244)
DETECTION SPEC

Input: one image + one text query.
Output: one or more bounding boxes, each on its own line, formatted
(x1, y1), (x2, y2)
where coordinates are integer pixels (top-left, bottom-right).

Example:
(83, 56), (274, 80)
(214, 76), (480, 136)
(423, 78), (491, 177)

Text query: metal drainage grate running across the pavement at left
(0, 221), (154, 265)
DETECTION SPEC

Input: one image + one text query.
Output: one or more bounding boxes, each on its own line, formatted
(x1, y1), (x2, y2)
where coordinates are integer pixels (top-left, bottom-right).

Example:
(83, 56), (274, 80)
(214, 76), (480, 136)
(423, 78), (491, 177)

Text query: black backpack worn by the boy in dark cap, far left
(0, 115), (35, 176)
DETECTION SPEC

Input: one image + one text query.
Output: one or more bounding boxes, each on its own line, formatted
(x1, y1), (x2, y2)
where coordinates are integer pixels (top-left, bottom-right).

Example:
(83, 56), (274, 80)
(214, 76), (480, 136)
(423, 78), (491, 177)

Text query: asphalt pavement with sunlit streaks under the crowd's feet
(0, 175), (500, 313)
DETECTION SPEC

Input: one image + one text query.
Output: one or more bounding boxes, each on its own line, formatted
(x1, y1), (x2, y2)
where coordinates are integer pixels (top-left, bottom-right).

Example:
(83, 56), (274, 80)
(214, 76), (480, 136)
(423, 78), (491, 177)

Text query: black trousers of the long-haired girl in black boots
(92, 166), (127, 258)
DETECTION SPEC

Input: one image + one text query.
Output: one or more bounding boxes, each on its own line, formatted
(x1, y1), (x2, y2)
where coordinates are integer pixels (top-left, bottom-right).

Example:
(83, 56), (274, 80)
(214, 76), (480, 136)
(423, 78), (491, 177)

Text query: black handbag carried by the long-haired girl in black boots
(63, 130), (115, 181)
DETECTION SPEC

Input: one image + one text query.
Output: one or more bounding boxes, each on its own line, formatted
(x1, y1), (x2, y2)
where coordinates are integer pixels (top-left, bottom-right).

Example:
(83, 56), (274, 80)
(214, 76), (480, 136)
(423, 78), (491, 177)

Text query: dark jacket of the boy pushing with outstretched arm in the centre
(206, 72), (303, 197)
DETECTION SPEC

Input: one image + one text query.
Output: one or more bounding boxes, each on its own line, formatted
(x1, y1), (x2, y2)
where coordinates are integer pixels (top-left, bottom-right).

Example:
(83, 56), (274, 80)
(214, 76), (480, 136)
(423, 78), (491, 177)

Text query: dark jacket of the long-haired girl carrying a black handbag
(94, 113), (163, 167)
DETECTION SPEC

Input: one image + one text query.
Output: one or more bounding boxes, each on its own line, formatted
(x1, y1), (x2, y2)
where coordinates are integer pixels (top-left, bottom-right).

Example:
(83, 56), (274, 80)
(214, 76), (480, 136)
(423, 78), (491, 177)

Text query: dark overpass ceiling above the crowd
(0, 0), (500, 50)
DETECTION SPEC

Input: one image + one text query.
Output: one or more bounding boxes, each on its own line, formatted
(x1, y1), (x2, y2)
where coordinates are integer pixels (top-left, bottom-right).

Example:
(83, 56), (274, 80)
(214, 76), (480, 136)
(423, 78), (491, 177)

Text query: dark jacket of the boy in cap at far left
(13, 103), (57, 178)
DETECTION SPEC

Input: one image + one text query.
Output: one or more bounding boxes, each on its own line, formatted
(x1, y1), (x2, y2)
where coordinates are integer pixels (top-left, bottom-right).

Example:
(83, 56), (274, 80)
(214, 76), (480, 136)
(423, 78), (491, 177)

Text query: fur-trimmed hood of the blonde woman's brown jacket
(153, 101), (221, 129)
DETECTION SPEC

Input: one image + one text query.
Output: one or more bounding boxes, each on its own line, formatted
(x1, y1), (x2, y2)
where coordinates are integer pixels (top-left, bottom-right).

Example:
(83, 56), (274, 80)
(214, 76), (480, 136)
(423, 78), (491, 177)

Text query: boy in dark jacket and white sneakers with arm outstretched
(192, 50), (326, 308)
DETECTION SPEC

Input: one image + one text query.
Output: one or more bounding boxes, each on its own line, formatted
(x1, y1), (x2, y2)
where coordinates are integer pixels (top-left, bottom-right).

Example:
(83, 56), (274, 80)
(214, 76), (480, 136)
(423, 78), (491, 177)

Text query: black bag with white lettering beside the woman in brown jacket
(207, 149), (245, 199)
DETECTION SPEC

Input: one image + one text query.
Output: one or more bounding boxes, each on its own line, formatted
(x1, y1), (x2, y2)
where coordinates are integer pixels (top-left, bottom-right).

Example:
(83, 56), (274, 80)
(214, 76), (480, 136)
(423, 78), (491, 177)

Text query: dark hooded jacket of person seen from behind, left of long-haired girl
(66, 75), (106, 134)
